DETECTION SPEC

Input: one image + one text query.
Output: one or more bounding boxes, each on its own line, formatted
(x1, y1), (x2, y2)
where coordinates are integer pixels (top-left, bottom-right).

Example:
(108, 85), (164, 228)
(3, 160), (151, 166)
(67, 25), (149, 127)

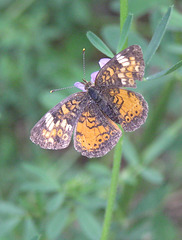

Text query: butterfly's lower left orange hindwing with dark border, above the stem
(74, 100), (122, 158)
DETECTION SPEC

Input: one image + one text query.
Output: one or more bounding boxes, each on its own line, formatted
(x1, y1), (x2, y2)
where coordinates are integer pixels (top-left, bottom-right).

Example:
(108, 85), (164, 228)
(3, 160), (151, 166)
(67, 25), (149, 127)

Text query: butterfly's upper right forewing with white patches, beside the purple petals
(95, 45), (145, 88)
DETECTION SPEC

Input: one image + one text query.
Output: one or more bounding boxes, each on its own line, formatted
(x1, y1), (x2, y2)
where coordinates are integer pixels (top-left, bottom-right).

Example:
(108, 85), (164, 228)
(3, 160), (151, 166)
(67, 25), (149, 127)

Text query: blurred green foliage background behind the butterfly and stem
(0, 0), (182, 240)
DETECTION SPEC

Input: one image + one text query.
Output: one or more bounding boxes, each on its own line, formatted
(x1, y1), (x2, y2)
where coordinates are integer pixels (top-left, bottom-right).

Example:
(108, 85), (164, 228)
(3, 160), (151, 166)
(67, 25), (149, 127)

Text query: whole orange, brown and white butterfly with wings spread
(30, 45), (148, 158)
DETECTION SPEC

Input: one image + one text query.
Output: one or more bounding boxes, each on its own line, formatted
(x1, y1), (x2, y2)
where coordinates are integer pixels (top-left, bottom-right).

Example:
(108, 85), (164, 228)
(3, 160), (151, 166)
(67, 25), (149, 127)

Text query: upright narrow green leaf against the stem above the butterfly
(116, 14), (133, 53)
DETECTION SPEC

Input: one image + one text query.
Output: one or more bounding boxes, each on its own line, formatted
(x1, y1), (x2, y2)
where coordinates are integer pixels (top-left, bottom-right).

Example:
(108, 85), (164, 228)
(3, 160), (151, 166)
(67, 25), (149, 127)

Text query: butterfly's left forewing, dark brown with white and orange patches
(30, 92), (88, 150)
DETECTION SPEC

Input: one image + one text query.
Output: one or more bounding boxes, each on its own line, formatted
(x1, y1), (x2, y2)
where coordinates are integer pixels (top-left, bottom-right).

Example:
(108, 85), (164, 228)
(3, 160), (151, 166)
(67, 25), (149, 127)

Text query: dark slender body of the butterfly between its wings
(88, 86), (119, 123)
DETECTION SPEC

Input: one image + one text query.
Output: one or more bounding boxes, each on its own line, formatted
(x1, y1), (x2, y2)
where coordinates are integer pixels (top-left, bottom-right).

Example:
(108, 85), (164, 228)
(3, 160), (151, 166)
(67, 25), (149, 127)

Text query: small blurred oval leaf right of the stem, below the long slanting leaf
(141, 168), (163, 184)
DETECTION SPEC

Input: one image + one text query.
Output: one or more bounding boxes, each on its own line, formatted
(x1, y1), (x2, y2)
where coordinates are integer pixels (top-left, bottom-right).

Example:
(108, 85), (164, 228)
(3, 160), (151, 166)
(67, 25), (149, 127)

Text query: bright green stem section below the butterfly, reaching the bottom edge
(100, 130), (123, 240)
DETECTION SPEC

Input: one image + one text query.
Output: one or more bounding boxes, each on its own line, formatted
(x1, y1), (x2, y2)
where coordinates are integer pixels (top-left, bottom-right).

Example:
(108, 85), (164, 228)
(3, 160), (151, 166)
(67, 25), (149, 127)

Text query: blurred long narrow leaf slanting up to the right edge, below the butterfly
(143, 119), (182, 164)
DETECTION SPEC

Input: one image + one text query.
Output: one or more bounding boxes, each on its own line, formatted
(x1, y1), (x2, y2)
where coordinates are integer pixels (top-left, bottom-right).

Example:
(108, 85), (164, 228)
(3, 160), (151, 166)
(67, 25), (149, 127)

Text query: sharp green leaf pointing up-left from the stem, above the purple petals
(87, 31), (114, 58)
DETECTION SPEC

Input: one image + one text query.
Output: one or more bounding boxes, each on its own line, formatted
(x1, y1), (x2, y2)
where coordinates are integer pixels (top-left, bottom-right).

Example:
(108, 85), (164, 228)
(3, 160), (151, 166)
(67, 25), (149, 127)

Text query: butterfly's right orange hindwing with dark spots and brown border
(101, 87), (148, 132)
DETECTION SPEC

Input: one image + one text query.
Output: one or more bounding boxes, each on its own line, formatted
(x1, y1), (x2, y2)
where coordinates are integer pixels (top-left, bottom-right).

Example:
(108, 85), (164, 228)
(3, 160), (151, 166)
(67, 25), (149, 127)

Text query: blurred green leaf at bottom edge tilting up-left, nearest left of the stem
(76, 208), (102, 240)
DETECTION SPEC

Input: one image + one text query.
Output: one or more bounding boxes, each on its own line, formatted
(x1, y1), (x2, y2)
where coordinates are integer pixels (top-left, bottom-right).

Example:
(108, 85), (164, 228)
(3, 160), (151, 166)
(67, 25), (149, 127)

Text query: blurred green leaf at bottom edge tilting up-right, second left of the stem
(46, 208), (69, 239)
